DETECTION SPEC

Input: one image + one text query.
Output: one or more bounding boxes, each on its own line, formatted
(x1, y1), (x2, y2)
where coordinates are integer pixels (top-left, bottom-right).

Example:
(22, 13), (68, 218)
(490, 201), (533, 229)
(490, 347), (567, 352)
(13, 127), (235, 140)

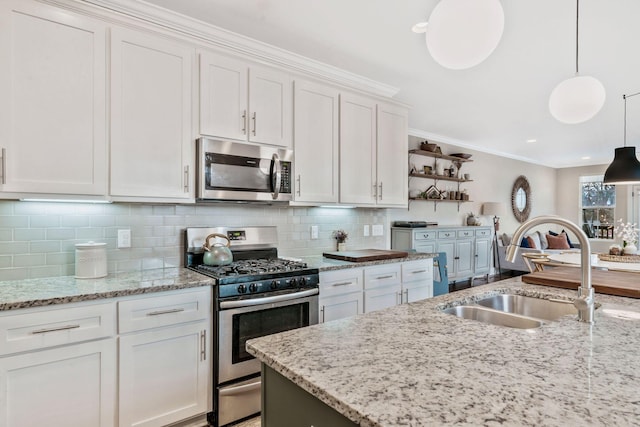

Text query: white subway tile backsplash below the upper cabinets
(0, 201), (388, 280)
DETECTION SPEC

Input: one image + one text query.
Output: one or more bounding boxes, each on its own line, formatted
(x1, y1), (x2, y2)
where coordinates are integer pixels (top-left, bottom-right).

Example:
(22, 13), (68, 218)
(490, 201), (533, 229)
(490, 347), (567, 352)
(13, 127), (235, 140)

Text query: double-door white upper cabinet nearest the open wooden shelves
(340, 94), (408, 207)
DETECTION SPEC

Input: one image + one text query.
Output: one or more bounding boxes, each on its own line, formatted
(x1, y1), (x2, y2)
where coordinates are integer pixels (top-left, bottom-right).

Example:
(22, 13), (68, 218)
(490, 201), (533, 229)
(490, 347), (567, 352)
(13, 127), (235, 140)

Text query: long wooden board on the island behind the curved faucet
(522, 267), (640, 298)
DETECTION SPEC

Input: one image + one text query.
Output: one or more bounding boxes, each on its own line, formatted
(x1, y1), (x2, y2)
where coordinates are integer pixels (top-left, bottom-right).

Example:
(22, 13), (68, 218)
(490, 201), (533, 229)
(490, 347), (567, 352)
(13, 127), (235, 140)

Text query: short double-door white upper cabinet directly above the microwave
(200, 52), (293, 147)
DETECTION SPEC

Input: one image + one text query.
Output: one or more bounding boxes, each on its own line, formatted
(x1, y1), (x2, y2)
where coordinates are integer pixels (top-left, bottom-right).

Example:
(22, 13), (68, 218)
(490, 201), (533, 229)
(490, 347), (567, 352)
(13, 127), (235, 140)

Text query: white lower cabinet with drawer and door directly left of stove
(118, 288), (211, 427)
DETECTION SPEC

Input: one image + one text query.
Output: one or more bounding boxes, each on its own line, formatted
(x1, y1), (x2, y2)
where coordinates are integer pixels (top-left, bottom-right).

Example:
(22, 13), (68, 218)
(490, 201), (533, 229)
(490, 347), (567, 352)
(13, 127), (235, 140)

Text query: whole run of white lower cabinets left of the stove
(0, 287), (212, 427)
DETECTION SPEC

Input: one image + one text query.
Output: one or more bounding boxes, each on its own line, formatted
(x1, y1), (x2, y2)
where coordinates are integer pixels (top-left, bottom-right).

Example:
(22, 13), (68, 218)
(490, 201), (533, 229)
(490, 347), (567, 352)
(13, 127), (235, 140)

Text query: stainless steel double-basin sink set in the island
(442, 294), (578, 329)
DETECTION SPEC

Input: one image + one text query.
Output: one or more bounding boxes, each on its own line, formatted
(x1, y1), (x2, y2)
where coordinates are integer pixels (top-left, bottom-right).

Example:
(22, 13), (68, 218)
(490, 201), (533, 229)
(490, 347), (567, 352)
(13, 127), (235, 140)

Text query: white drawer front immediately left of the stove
(118, 286), (211, 333)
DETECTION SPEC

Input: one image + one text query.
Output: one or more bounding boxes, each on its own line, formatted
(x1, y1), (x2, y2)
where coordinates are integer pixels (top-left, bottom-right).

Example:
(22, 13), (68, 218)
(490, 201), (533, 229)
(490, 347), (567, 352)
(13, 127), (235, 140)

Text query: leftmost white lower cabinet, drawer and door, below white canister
(0, 304), (117, 427)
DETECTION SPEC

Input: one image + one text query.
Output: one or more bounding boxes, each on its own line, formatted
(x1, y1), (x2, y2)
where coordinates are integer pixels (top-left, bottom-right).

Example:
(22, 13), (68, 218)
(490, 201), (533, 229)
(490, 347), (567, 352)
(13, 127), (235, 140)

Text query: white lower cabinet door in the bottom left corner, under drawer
(0, 338), (116, 427)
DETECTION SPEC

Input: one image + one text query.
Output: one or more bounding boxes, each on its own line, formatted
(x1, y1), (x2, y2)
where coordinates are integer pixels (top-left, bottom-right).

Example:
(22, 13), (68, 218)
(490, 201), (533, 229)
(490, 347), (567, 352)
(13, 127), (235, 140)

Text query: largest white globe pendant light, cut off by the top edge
(412, 0), (504, 70)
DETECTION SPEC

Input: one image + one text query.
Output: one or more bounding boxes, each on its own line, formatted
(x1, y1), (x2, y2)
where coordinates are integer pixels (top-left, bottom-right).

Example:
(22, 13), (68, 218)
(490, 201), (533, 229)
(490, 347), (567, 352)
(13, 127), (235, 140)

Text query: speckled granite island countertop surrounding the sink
(247, 278), (640, 427)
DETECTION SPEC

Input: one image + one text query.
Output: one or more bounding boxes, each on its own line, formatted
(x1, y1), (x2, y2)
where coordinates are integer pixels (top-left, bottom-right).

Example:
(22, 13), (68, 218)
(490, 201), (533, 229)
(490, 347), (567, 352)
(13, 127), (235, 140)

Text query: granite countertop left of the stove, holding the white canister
(0, 267), (212, 311)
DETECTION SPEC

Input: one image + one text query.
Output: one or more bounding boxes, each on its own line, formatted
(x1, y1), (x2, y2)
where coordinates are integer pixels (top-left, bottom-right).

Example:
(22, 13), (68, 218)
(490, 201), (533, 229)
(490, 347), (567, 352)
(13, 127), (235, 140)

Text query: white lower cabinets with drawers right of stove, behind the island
(319, 258), (433, 323)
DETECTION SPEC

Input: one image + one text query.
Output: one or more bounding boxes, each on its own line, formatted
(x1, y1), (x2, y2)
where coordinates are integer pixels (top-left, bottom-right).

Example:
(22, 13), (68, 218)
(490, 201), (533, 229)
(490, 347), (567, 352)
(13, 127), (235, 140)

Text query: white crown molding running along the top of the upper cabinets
(71, 0), (400, 98)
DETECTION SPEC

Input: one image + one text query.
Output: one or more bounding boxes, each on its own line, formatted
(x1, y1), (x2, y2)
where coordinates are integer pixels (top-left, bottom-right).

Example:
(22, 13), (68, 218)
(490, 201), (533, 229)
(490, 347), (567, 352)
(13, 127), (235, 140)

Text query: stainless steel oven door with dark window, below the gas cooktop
(218, 288), (318, 384)
